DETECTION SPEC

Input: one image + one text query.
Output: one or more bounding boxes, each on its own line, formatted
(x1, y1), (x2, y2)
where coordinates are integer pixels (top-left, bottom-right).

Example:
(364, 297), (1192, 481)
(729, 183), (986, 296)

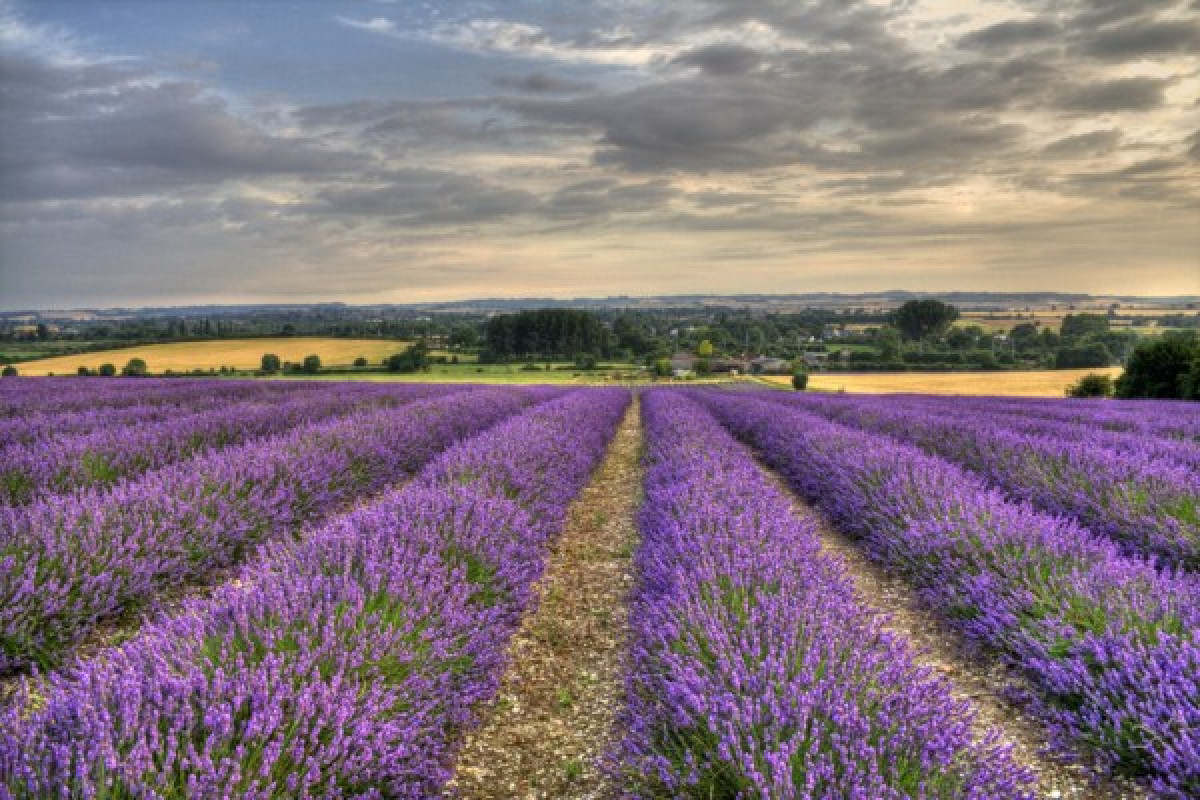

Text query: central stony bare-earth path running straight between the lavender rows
(446, 399), (642, 800)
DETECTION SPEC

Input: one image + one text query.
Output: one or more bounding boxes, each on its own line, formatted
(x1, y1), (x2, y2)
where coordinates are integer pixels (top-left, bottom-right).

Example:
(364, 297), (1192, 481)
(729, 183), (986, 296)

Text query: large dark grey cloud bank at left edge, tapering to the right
(0, 50), (364, 200)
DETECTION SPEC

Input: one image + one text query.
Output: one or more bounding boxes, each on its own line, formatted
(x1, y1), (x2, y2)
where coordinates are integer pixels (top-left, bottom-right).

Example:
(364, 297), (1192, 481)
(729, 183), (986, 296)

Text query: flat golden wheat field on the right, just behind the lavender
(767, 367), (1121, 397)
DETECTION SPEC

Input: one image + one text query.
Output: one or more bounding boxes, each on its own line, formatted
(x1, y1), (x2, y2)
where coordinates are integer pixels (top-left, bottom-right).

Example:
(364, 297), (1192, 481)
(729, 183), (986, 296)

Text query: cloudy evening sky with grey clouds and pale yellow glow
(0, 0), (1200, 309)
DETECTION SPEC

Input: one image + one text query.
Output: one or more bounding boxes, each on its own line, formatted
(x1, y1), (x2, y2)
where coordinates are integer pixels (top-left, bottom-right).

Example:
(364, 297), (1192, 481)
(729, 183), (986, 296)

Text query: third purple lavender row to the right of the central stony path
(768, 395), (1200, 570)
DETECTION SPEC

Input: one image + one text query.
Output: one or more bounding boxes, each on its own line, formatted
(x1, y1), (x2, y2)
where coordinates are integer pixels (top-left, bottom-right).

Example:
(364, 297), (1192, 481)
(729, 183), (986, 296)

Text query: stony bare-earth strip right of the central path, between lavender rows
(780, 491), (1148, 800)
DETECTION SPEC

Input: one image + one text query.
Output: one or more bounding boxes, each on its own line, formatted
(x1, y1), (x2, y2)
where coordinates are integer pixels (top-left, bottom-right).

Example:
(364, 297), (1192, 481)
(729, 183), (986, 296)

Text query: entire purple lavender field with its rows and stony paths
(0, 379), (1200, 800)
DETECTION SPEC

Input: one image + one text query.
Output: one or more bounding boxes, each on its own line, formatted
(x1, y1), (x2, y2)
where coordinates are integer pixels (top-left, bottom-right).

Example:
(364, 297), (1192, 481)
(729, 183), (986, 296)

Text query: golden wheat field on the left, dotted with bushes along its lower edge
(7, 336), (420, 375)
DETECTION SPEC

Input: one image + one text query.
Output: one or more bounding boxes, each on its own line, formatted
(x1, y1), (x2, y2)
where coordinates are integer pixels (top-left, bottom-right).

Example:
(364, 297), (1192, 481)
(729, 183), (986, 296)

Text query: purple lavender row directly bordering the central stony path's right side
(617, 391), (1032, 800)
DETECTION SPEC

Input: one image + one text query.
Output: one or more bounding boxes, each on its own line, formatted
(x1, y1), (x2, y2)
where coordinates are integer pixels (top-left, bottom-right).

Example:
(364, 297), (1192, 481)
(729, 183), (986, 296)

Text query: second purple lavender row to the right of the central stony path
(701, 393), (1200, 800)
